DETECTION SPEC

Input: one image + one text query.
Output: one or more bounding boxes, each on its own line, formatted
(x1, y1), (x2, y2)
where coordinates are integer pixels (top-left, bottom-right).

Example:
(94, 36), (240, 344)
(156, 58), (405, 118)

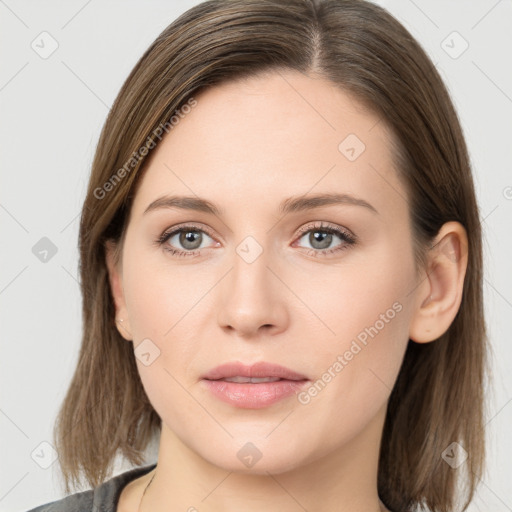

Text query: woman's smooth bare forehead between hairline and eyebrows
(133, 71), (406, 220)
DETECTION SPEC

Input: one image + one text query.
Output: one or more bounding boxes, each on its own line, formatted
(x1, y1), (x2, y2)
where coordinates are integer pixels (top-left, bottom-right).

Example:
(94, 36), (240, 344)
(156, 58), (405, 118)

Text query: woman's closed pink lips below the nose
(201, 362), (309, 409)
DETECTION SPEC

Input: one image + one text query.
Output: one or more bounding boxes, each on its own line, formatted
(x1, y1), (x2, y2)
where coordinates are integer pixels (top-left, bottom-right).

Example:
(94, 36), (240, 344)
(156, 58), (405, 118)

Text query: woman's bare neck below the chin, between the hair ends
(141, 407), (386, 512)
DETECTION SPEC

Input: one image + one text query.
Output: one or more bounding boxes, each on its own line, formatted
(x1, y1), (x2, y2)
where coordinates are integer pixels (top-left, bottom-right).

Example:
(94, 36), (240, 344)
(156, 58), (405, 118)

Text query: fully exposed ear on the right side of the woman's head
(409, 221), (468, 343)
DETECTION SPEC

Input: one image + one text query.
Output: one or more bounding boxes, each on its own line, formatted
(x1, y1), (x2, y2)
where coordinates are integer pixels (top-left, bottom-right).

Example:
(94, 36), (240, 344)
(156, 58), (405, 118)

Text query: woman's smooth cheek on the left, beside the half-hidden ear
(123, 248), (214, 398)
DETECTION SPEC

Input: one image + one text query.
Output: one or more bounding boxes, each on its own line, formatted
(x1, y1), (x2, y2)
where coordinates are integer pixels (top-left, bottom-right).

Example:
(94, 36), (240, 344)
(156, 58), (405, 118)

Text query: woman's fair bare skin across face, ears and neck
(107, 71), (467, 512)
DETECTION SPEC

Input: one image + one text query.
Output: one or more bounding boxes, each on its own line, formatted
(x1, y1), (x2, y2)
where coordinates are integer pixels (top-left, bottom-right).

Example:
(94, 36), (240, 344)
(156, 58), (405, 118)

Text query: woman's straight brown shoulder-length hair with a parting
(54, 0), (488, 512)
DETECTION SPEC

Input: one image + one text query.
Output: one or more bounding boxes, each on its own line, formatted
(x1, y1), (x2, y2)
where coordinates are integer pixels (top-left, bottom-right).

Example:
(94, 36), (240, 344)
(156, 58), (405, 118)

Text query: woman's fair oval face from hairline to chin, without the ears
(107, 71), (416, 473)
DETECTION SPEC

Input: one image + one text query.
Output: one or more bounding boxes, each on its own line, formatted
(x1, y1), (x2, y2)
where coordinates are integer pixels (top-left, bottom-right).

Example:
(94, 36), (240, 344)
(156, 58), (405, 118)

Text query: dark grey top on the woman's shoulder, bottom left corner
(27, 463), (156, 512)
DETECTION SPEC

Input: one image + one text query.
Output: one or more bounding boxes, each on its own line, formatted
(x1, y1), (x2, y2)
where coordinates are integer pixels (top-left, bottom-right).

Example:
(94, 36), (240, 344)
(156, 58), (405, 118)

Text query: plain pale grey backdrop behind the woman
(0, 0), (512, 512)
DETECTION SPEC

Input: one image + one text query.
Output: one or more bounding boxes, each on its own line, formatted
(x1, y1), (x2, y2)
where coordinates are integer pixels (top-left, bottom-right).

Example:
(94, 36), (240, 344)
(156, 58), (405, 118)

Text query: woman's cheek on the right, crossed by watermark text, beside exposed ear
(292, 247), (414, 410)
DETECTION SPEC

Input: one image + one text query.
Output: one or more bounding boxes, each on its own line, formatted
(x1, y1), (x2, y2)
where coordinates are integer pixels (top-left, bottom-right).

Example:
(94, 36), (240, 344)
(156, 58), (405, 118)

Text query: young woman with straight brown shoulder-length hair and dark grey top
(27, 0), (487, 512)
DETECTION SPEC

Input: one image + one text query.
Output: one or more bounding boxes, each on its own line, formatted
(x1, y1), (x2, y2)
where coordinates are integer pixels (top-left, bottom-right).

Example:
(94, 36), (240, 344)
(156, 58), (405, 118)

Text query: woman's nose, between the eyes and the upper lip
(217, 241), (289, 337)
